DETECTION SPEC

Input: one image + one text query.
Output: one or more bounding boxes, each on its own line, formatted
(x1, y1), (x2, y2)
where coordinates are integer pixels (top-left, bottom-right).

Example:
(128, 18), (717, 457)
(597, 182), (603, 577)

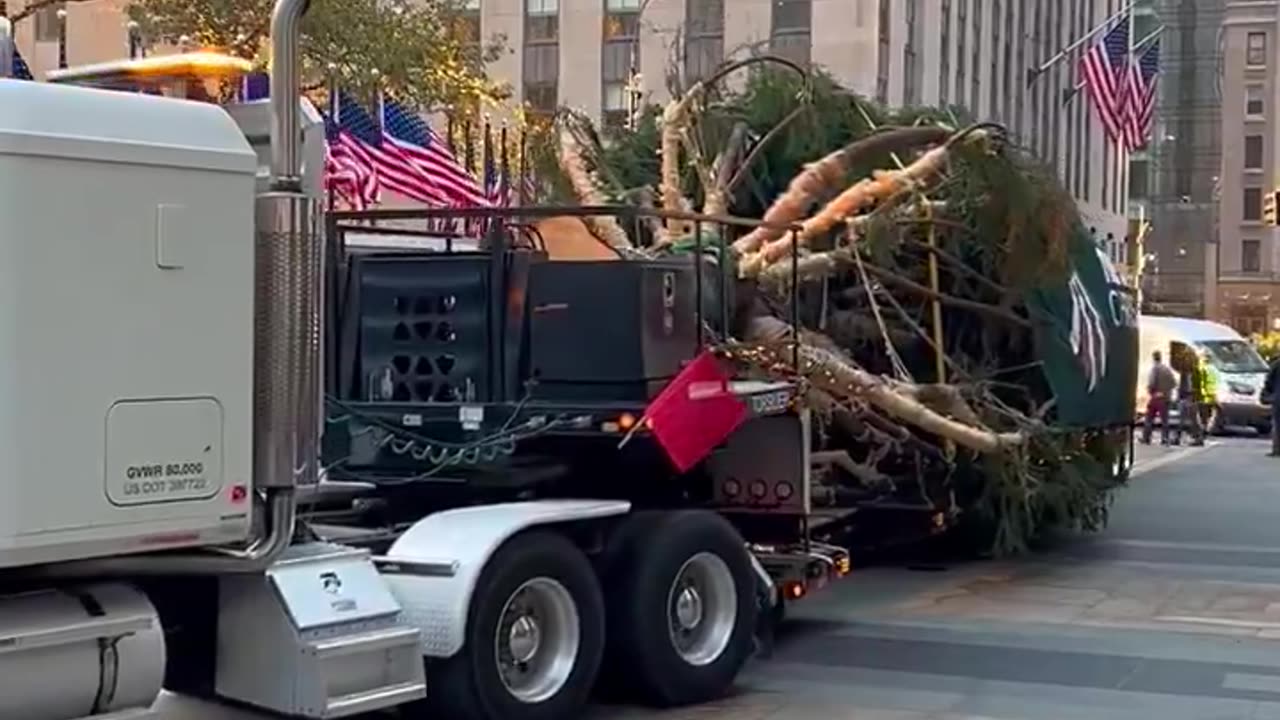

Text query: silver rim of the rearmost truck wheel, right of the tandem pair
(667, 552), (737, 666)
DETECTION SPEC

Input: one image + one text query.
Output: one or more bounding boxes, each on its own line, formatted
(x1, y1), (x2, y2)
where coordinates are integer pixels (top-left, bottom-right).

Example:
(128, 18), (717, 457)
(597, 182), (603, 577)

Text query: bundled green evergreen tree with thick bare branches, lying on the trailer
(537, 68), (1121, 553)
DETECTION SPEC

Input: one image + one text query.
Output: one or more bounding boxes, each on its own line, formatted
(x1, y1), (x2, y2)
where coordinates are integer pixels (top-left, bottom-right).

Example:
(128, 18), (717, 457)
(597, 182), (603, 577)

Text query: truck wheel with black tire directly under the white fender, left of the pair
(420, 530), (604, 720)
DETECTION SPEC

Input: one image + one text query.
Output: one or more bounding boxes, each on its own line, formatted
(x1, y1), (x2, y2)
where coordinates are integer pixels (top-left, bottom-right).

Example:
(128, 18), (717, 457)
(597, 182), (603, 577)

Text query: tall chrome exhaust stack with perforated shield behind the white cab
(46, 0), (324, 575)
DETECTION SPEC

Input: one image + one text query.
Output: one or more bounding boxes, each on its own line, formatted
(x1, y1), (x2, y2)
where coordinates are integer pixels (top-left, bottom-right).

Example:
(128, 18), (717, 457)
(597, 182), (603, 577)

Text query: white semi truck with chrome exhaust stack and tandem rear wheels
(0, 0), (849, 720)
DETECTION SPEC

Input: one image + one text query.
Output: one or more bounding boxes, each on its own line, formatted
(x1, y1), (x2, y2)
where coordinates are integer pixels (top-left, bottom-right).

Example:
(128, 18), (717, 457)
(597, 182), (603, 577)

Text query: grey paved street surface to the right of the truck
(165, 438), (1280, 720)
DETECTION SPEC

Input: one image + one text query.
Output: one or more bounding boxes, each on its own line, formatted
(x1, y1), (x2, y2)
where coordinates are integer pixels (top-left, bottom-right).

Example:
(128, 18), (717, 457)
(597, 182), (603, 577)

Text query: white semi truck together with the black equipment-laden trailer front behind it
(0, 0), (850, 720)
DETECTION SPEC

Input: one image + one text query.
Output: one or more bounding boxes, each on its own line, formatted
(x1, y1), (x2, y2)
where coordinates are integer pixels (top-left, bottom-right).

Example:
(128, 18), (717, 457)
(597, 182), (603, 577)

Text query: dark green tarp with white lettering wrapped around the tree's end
(1027, 231), (1138, 428)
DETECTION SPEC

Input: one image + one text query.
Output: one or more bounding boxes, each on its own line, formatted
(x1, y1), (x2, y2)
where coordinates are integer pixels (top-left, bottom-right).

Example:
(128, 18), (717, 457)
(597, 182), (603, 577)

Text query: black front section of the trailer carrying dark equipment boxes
(318, 208), (851, 610)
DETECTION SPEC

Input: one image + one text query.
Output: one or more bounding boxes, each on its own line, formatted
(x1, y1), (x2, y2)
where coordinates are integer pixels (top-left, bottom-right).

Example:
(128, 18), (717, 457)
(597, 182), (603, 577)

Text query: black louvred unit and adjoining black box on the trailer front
(333, 242), (723, 404)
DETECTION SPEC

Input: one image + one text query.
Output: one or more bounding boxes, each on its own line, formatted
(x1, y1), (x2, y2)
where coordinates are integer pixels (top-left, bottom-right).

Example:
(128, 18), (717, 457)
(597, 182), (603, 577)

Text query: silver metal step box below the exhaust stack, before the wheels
(215, 543), (426, 719)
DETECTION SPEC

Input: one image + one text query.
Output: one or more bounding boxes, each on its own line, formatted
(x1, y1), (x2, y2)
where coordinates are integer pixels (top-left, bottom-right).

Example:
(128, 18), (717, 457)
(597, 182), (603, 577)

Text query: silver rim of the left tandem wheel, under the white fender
(494, 578), (581, 703)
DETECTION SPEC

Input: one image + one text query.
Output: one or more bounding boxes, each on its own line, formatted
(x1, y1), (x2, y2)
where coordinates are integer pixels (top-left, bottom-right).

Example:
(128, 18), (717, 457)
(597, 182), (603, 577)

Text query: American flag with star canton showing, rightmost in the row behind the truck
(381, 100), (490, 208)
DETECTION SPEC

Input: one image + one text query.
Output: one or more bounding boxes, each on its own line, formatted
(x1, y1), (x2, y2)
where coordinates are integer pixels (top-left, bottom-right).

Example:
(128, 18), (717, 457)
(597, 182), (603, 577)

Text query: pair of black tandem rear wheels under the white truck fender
(426, 511), (756, 720)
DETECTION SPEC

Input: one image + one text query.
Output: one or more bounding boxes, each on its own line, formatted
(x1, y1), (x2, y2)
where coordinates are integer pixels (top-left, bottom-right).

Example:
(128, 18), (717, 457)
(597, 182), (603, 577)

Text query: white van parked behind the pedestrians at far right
(1137, 315), (1271, 434)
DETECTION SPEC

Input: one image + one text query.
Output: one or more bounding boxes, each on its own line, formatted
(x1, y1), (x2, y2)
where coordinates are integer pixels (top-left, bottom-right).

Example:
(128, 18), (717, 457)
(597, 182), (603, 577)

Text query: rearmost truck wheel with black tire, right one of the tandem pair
(605, 510), (759, 707)
